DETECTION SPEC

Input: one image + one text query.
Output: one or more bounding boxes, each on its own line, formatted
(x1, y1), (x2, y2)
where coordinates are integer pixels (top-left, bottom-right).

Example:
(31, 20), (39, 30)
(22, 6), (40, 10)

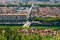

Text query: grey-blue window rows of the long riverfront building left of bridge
(0, 15), (26, 20)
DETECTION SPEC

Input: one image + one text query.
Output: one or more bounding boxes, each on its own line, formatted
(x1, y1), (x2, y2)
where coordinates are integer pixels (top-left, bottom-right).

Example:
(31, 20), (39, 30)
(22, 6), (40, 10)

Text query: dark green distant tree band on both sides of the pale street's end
(0, 3), (60, 7)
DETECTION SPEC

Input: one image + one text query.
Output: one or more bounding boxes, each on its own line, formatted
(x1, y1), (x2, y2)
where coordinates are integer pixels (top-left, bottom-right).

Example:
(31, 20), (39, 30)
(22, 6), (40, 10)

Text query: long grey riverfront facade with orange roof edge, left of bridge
(0, 14), (27, 24)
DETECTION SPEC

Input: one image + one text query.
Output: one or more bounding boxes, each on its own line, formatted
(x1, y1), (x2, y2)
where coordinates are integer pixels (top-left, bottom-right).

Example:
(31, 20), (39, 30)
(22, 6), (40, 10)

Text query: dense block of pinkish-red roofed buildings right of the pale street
(31, 7), (60, 17)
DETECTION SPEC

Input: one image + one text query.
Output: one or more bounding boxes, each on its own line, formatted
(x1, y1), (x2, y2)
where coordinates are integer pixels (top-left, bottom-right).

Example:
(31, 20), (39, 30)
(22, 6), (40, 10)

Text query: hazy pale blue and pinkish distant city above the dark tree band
(0, 0), (60, 4)
